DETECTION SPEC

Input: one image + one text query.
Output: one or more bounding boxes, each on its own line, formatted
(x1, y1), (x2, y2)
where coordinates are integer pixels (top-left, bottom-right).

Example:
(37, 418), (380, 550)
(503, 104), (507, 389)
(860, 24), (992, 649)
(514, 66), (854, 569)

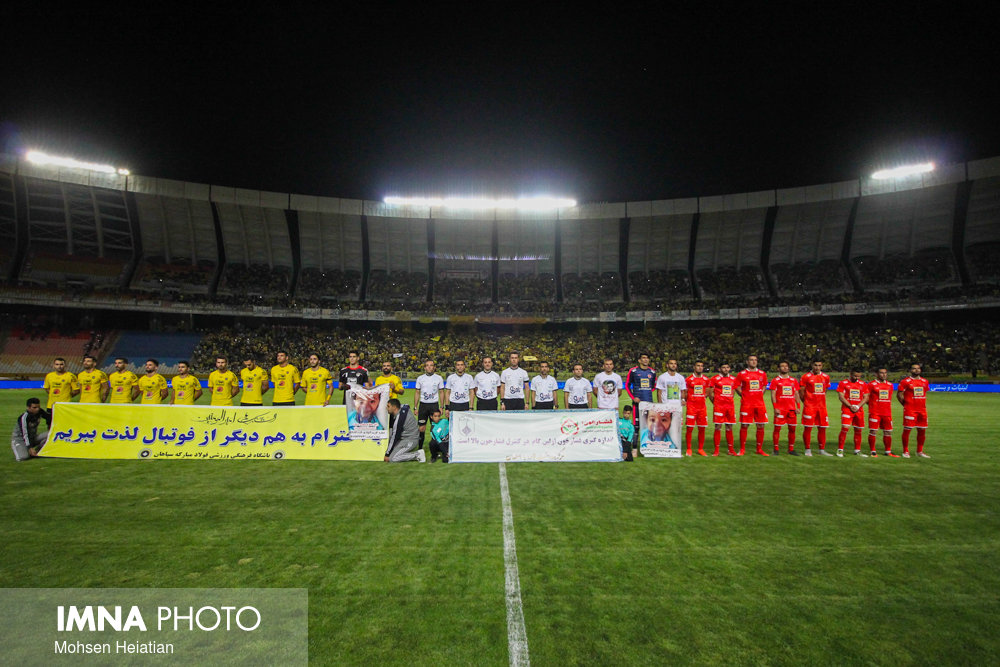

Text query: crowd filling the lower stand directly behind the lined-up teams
(193, 320), (1000, 377)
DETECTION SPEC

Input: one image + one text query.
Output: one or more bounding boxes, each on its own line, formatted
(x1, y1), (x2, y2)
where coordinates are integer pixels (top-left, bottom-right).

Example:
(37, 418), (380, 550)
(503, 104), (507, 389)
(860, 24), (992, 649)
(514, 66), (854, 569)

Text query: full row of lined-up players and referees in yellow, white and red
(37, 351), (929, 458)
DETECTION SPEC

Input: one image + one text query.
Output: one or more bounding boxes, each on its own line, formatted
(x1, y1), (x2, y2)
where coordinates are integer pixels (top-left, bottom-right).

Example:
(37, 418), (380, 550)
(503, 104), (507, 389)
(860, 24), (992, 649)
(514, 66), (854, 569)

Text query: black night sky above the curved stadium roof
(0, 3), (1000, 202)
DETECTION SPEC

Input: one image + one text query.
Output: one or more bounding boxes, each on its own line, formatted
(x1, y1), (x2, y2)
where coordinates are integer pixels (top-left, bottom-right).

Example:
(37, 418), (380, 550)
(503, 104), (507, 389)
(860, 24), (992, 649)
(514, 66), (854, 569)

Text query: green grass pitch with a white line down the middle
(0, 390), (1000, 665)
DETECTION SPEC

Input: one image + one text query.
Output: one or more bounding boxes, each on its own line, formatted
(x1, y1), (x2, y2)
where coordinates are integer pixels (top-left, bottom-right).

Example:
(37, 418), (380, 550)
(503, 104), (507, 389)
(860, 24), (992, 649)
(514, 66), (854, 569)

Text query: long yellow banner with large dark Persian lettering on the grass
(39, 403), (387, 461)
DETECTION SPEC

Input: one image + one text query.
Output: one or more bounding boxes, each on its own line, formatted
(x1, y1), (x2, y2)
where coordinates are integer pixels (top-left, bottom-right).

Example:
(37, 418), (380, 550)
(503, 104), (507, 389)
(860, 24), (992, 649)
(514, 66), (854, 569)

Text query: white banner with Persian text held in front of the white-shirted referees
(450, 410), (622, 463)
